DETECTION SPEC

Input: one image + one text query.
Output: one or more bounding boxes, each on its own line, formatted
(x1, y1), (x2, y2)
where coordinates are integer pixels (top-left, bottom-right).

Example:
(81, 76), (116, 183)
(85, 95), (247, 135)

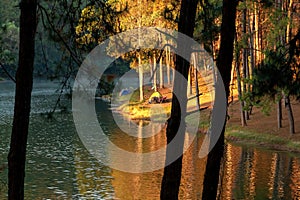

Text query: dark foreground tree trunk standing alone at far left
(8, 0), (37, 200)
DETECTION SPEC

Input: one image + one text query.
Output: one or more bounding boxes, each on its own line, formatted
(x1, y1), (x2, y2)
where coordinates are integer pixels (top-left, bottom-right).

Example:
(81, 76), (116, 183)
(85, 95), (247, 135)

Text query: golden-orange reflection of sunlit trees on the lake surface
(75, 128), (300, 200)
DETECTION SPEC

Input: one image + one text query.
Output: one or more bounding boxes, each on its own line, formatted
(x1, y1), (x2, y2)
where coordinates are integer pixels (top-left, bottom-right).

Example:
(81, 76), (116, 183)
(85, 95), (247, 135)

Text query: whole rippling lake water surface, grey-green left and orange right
(0, 81), (300, 200)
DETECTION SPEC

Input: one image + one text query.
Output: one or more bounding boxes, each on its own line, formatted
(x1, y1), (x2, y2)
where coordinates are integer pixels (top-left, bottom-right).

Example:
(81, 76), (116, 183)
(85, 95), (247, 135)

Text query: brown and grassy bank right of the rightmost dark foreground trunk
(226, 100), (300, 153)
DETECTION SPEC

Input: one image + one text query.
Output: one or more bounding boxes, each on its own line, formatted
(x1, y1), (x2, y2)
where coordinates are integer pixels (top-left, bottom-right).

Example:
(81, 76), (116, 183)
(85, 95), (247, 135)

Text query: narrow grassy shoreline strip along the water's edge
(114, 99), (300, 154)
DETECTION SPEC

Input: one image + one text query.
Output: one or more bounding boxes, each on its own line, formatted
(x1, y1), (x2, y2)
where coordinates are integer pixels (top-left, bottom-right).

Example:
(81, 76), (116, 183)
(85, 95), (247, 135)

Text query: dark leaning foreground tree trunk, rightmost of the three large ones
(202, 0), (238, 200)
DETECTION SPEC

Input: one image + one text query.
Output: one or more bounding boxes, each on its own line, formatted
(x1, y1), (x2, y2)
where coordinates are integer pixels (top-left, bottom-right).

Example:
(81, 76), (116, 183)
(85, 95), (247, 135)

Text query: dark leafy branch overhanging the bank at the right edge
(252, 29), (300, 98)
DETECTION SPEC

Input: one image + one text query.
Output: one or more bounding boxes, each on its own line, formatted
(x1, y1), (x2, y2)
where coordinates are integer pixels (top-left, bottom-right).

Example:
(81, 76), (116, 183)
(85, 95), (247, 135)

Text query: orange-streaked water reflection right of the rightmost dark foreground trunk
(221, 144), (300, 199)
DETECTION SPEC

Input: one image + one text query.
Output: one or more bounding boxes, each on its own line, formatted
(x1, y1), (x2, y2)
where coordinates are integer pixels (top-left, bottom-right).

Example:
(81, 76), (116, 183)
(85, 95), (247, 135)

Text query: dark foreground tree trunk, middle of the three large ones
(160, 0), (198, 200)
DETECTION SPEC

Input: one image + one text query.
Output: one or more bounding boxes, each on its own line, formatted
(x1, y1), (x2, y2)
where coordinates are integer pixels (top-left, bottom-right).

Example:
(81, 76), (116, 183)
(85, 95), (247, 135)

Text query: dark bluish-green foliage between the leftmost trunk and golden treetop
(35, 0), (86, 79)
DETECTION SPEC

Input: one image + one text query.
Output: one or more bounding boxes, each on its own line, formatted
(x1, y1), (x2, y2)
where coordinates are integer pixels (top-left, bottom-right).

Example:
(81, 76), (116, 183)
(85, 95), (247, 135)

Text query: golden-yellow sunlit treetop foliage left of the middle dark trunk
(76, 0), (179, 71)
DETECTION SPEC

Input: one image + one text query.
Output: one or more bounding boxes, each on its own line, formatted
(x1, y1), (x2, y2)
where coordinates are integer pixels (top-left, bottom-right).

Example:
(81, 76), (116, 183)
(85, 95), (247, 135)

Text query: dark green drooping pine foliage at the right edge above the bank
(247, 37), (300, 113)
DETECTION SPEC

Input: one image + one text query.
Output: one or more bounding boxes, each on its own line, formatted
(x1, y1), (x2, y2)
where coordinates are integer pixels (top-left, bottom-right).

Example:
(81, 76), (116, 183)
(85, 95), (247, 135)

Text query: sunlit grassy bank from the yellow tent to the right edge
(118, 89), (300, 153)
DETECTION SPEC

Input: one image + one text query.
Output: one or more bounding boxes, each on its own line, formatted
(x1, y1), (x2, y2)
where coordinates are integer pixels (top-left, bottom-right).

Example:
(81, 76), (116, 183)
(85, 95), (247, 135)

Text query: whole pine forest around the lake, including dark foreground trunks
(0, 0), (300, 200)
